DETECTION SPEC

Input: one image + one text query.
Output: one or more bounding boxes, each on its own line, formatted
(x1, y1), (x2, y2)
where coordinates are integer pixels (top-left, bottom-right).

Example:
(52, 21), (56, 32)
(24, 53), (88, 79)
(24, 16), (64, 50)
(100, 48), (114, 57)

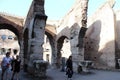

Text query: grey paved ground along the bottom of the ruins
(0, 69), (120, 80)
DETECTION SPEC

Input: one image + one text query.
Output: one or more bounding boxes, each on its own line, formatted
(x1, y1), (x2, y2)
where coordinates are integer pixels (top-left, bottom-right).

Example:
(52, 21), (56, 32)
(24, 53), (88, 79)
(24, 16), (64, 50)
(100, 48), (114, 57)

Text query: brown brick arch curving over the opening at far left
(0, 14), (24, 42)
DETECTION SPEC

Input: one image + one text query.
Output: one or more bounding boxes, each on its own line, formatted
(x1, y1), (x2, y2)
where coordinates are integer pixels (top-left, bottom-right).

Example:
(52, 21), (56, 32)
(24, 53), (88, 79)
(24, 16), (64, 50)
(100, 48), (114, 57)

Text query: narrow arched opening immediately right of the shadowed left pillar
(43, 31), (56, 66)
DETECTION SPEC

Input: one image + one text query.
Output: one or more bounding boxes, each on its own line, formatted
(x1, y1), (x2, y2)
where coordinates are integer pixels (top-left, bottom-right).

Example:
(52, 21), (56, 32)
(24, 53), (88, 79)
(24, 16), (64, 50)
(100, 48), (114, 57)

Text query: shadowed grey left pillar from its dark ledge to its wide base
(28, 13), (47, 77)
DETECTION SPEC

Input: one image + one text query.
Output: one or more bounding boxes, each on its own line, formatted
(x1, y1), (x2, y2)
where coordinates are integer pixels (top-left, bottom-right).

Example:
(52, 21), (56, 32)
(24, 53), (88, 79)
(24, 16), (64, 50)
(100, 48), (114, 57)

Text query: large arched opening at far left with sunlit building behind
(0, 24), (20, 59)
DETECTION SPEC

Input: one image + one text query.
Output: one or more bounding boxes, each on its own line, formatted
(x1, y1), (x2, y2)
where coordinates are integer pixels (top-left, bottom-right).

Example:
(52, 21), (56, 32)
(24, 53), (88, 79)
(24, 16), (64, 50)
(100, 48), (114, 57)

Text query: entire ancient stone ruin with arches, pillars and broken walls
(0, 0), (120, 77)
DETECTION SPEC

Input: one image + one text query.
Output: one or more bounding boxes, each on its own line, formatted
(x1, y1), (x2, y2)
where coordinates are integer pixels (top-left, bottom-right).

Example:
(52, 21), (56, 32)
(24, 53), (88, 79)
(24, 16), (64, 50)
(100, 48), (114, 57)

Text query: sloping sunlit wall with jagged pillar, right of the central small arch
(57, 0), (88, 71)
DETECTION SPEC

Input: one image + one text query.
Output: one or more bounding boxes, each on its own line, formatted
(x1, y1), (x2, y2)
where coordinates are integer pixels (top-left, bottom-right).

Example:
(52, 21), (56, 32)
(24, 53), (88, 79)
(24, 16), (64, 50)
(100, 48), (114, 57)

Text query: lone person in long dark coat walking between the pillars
(66, 56), (73, 78)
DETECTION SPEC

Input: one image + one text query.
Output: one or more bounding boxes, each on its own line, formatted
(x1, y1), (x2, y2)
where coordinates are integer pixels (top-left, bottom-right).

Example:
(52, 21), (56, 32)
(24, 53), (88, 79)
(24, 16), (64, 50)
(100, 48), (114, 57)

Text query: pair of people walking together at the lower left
(1, 52), (21, 80)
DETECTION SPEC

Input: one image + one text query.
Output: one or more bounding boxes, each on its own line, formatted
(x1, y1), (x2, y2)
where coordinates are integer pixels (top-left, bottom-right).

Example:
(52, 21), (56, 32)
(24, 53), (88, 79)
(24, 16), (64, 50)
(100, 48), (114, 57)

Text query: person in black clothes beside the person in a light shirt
(11, 55), (21, 80)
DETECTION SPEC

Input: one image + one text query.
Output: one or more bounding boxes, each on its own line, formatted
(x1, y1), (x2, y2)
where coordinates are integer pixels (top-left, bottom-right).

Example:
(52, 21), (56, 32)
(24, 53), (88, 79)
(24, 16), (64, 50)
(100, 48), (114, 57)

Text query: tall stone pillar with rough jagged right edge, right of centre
(71, 0), (88, 72)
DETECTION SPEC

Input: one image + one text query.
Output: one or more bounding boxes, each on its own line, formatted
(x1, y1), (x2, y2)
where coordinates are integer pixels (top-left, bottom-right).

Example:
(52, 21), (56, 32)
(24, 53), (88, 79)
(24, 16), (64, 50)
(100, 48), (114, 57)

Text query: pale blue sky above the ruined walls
(0, 0), (120, 20)
